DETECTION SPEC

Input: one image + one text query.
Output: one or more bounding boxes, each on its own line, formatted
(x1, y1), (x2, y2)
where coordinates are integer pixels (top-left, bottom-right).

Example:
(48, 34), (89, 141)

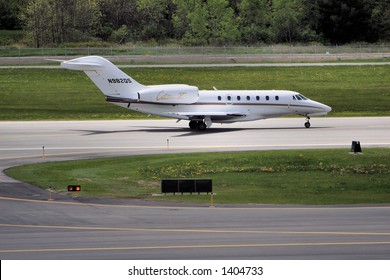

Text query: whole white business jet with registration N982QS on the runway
(61, 56), (331, 130)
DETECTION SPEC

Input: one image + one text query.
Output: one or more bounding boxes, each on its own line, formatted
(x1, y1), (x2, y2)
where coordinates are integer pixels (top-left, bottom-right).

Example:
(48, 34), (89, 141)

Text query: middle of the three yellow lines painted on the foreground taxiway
(0, 224), (390, 236)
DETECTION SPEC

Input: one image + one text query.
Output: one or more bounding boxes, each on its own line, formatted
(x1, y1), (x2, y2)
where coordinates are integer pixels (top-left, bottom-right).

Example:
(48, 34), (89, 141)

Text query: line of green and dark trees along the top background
(0, 0), (390, 47)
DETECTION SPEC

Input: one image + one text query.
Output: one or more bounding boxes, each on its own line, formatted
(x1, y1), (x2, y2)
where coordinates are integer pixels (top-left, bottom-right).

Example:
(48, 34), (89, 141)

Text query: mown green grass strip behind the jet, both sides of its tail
(0, 66), (390, 120)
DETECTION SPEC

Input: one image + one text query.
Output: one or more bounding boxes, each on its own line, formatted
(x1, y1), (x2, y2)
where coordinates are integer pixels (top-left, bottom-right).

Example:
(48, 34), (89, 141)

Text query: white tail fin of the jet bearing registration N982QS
(61, 56), (145, 99)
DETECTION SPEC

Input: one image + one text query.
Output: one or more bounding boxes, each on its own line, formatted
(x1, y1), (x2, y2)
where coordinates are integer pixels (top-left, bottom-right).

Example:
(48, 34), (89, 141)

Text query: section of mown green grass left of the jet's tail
(0, 69), (145, 120)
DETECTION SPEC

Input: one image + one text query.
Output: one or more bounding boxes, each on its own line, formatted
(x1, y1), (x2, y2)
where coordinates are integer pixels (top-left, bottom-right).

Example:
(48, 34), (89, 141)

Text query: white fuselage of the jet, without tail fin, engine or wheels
(114, 90), (331, 123)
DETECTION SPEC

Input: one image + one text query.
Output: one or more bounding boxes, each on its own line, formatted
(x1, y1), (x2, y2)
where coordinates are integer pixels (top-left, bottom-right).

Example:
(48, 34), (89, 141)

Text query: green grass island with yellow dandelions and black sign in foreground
(6, 149), (390, 205)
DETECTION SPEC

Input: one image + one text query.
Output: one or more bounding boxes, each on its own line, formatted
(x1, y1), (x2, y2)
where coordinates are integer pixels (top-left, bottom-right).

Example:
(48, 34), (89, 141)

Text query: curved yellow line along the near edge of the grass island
(0, 196), (390, 211)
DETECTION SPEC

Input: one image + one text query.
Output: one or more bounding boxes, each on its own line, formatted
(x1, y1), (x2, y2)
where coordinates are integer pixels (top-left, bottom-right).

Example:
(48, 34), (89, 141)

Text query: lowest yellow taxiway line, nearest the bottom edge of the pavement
(0, 241), (390, 253)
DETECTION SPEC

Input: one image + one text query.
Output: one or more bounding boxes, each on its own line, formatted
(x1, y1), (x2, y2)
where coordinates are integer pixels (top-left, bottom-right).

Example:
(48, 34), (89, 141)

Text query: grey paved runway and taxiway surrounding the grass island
(0, 117), (390, 259)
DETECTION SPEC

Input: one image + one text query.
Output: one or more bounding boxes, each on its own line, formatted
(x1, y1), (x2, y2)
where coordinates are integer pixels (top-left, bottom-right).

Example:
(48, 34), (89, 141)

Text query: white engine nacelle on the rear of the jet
(138, 85), (199, 104)
